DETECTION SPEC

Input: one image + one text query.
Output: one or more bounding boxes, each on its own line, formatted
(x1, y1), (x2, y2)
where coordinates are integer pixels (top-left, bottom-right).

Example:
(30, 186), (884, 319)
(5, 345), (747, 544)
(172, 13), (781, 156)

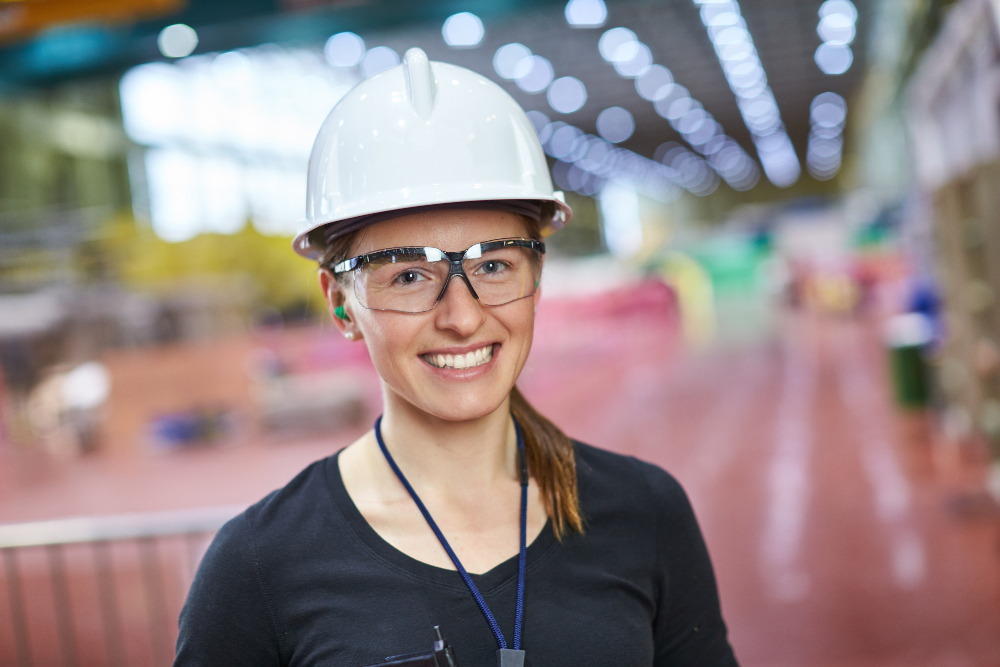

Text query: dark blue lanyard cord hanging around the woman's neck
(375, 416), (528, 650)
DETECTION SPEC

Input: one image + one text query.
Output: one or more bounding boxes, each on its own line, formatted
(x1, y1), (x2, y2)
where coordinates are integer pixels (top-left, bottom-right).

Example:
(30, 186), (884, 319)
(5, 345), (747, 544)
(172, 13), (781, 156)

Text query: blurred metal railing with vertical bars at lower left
(0, 507), (244, 667)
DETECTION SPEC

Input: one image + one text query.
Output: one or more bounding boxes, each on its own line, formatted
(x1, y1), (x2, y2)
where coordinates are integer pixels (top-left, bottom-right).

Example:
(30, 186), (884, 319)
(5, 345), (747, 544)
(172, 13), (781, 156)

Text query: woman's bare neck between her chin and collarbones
(378, 396), (518, 495)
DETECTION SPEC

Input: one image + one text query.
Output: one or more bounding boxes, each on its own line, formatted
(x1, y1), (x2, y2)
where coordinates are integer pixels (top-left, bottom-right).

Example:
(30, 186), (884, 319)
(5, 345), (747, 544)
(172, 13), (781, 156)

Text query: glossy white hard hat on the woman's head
(292, 49), (573, 259)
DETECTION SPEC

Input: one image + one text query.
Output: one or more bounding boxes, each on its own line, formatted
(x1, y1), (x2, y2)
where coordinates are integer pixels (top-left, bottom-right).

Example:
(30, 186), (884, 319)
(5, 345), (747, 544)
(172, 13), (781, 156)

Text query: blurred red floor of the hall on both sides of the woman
(0, 310), (1000, 667)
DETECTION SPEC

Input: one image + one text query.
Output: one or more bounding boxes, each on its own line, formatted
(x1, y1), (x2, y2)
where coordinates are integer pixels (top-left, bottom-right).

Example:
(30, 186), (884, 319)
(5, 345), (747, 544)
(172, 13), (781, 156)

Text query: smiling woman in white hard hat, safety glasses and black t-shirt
(176, 49), (736, 667)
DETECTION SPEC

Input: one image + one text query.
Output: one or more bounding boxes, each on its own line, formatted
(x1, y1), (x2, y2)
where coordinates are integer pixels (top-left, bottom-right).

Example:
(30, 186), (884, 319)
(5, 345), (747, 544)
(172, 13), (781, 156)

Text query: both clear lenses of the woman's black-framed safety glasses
(354, 243), (542, 313)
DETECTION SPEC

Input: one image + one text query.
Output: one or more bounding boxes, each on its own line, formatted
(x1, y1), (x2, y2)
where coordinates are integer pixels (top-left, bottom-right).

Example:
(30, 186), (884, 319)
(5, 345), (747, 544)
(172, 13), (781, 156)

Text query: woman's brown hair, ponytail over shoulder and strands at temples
(314, 216), (583, 540)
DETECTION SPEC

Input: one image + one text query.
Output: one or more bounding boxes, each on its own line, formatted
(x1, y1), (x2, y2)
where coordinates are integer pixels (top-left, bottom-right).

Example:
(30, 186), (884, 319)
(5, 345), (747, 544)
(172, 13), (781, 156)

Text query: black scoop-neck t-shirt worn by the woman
(174, 444), (736, 667)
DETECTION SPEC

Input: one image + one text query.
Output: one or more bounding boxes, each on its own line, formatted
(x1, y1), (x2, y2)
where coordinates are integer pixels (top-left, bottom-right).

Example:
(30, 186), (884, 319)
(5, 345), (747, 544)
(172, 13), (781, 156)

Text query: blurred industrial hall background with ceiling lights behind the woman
(0, 0), (1000, 667)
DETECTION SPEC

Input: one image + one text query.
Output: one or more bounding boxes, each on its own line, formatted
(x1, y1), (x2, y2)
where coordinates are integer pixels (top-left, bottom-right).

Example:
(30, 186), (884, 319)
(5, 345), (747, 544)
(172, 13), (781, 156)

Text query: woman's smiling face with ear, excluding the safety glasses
(322, 209), (540, 421)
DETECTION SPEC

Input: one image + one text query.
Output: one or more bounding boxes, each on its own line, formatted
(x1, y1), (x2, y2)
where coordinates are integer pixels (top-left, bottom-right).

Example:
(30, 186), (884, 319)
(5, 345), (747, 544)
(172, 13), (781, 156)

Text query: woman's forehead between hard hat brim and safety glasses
(351, 209), (528, 255)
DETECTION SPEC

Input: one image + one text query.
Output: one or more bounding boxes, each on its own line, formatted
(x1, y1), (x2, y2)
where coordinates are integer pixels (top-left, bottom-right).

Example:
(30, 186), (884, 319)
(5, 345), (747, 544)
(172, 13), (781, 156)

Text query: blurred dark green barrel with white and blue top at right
(886, 313), (933, 410)
